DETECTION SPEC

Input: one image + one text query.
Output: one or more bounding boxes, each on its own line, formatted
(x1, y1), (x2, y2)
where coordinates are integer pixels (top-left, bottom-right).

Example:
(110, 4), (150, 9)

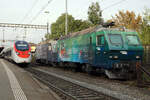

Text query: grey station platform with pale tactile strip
(0, 59), (57, 100)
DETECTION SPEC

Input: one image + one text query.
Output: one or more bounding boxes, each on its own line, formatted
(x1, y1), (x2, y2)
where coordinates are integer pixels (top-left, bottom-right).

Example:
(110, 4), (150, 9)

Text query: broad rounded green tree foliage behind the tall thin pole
(45, 14), (91, 40)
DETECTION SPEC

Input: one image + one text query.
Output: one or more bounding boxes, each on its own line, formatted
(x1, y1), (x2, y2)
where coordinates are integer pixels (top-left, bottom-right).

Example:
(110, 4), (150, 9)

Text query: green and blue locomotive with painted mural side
(57, 23), (143, 78)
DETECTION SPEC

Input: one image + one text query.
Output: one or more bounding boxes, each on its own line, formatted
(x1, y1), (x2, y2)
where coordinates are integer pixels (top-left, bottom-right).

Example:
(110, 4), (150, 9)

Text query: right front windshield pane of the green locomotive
(126, 35), (140, 45)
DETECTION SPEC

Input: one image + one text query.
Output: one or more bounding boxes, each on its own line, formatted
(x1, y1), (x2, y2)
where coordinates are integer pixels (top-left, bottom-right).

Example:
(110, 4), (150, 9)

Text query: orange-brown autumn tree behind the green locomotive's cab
(109, 10), (142, 32)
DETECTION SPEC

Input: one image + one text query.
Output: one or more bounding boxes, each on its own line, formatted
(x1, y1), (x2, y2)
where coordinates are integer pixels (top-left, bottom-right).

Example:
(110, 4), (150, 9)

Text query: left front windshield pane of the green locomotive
(108, 34), (123, 45)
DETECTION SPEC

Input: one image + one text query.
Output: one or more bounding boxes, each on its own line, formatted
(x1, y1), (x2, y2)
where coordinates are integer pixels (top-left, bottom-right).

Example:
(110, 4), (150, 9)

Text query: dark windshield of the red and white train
(15, 41), (29, 51)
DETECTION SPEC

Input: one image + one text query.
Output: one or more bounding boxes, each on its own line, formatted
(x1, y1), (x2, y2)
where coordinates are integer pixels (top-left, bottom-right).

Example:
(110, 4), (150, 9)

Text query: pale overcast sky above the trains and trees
(0, 0), (150, 45)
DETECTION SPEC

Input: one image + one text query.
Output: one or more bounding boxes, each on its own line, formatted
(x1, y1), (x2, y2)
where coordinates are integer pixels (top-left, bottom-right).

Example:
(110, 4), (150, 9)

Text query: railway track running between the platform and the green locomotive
(26, 68), (118, 100)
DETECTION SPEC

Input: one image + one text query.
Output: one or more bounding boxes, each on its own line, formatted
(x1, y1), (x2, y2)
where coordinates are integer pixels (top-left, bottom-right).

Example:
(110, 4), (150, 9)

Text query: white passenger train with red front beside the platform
(2, 41), (31, 64)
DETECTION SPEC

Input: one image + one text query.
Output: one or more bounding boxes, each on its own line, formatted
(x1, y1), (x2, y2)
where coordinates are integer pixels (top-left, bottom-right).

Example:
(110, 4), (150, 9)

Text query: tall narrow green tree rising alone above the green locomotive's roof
(88, 2), (103, 25)
